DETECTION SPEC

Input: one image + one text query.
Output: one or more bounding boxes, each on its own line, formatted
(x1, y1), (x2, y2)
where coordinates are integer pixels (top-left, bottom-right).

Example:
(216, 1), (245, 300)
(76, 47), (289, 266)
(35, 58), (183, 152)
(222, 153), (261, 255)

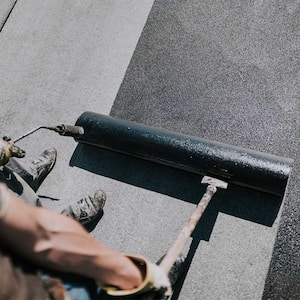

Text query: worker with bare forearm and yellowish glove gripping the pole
(0, 139), (170, 300)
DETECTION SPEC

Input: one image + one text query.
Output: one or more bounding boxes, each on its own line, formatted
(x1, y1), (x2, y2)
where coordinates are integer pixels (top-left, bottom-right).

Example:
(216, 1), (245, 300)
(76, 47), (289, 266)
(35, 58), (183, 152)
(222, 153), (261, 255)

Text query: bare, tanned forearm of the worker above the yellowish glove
(0, 185), (143, 289)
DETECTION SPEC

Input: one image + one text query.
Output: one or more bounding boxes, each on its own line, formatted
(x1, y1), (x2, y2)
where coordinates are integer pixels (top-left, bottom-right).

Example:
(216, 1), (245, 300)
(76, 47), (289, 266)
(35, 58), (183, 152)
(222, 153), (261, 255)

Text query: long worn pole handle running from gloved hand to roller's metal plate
(159, 185), (217, 274)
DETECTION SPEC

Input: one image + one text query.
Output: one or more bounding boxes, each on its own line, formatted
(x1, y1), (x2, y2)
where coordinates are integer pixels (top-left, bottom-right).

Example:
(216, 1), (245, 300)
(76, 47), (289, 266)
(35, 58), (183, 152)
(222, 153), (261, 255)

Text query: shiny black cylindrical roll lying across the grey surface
(75, 112), (293, 197)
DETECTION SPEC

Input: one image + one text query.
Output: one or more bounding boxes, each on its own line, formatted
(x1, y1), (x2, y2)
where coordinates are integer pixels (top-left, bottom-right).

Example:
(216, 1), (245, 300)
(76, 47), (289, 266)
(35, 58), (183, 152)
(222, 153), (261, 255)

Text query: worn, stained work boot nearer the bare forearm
(61, 190), (106, 225)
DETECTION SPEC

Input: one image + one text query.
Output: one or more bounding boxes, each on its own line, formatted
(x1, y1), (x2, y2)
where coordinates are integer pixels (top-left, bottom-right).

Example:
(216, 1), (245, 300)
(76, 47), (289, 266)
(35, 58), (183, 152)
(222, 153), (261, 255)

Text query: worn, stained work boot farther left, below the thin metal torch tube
(5, 148), (57, 192)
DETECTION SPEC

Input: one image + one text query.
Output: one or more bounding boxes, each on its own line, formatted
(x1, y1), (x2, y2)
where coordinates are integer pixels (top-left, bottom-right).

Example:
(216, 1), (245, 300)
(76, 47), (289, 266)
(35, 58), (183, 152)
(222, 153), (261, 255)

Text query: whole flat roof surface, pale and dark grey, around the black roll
(0, 0), (299, 300)
